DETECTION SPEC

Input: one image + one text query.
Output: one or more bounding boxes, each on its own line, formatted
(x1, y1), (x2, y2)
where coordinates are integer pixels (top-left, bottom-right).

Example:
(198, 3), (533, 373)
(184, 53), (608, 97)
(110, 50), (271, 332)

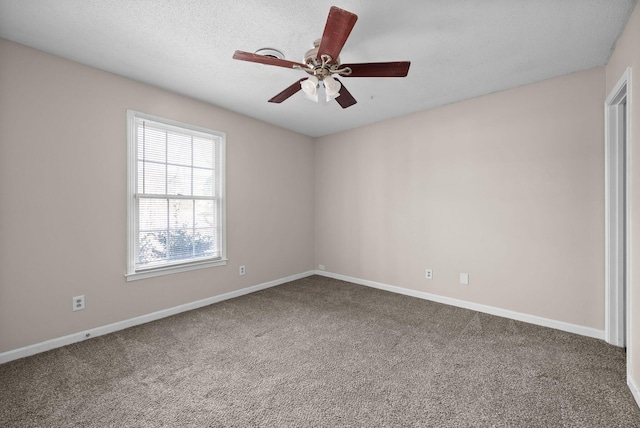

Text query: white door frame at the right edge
(604, 67), (631, 347)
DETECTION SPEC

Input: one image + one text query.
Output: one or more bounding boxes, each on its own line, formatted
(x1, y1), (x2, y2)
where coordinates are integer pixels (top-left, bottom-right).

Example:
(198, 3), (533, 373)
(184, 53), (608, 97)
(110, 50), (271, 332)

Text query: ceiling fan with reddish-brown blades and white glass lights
(233, 6), (411, 108)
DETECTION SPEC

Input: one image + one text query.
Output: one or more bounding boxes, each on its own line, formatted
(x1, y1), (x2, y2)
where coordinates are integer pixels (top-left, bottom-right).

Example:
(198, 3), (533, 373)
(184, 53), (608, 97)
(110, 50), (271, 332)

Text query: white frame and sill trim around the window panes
(125, 109), (227, 281)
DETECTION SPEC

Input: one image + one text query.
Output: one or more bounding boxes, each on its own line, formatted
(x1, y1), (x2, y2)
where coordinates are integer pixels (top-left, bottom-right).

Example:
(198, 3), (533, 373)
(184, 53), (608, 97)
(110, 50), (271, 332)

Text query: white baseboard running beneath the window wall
(0, 271), (314, 364)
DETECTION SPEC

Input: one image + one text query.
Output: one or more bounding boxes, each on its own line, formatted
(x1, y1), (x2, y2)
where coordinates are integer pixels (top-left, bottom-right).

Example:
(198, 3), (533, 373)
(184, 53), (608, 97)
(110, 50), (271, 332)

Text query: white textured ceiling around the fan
(0, 0), (636, 136)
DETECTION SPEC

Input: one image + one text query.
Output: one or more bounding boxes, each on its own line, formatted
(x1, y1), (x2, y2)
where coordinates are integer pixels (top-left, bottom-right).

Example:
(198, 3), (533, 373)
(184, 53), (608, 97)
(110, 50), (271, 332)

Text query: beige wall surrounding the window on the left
(0, 40), (314, 352)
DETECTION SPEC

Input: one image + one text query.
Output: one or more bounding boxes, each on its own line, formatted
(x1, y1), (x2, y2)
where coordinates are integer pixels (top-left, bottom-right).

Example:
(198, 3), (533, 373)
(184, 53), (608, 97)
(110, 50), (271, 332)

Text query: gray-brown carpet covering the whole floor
(0, 276), (640, 427)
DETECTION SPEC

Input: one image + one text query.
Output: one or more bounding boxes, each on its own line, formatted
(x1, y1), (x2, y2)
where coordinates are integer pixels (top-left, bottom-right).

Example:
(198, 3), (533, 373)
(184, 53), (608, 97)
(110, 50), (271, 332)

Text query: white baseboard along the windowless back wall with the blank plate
(315, 270), (604, 340)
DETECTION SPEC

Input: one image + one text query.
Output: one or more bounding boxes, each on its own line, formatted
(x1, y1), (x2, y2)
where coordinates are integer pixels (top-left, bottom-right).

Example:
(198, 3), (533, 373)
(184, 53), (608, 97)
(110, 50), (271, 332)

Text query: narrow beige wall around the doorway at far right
(606, 2), (640, 398)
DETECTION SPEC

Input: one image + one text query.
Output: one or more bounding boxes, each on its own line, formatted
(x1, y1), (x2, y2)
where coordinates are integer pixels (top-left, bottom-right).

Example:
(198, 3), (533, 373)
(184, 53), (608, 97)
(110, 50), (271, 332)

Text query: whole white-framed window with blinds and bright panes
(127, 110), (226, 280)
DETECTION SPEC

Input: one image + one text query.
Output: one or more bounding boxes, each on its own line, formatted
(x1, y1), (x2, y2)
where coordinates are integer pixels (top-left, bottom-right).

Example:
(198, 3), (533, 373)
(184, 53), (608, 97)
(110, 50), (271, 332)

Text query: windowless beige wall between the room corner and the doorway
(315, 67), (604, 330)
